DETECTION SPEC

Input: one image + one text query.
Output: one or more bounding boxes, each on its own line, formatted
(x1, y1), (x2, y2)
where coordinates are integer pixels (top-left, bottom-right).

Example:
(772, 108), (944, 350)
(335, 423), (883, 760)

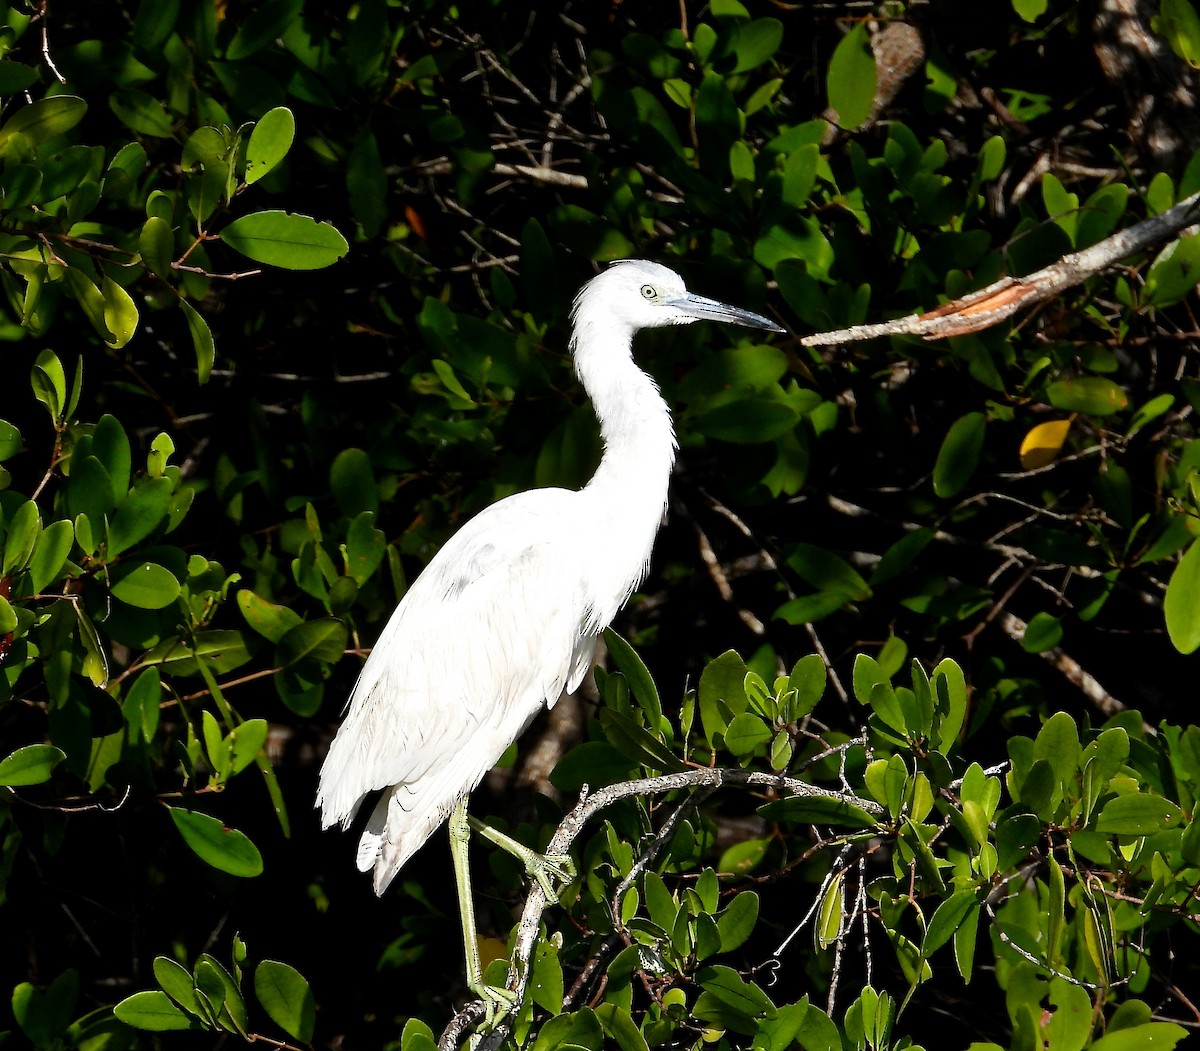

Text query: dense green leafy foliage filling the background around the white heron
(0, 0), (1200, 1051)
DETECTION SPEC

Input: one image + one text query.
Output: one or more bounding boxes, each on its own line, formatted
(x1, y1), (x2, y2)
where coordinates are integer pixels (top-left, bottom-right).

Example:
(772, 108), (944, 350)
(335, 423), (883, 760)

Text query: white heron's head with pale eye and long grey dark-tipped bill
(575, 259), (784, 332)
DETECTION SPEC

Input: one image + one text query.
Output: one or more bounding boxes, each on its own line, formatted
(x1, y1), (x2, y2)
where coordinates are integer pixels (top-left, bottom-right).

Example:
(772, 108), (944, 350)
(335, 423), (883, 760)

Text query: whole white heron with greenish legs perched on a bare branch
(317, 259), (784, 1008)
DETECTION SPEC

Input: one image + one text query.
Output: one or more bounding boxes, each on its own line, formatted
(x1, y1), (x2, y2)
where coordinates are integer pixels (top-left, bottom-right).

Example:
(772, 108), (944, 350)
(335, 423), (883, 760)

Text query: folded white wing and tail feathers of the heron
(317, 490), (595, 893)
